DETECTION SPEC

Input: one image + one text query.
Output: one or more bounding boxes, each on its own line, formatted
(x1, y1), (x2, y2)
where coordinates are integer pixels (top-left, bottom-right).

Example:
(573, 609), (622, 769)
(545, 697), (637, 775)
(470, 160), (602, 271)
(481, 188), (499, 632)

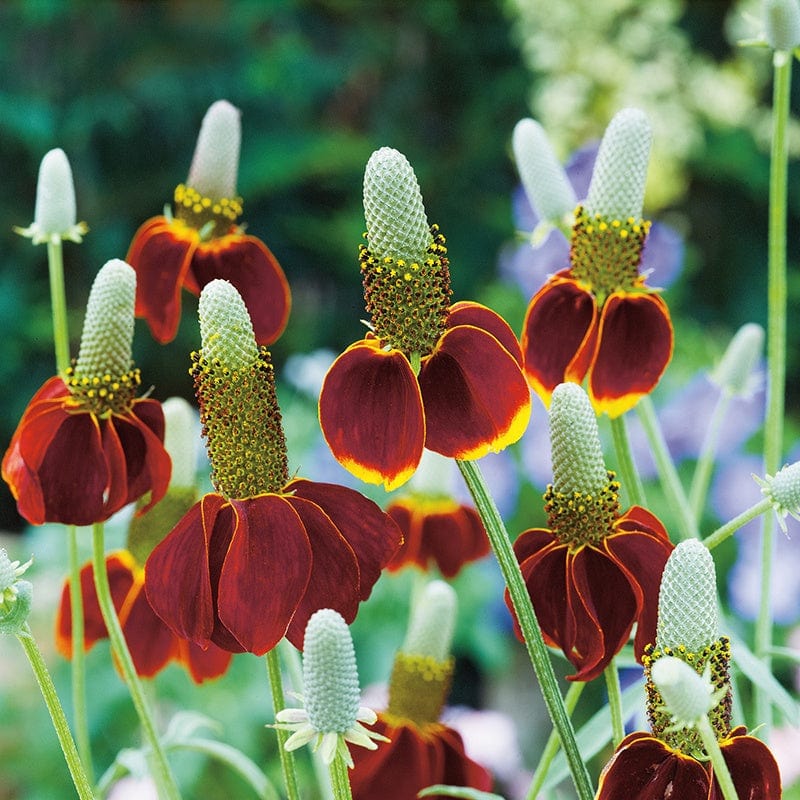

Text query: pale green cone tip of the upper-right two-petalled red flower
(585, 108), (652, 221)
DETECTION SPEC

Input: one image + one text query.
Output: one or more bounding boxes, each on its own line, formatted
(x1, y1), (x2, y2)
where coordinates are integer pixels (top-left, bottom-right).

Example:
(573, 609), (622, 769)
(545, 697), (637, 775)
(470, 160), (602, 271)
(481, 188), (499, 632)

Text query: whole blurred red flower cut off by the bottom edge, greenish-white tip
(350, 581), (492, 800)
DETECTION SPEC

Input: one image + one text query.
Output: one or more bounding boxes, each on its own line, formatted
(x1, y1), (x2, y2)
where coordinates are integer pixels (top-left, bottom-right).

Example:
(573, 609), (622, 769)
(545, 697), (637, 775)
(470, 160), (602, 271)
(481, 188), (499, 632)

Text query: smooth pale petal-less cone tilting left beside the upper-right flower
(511, 119), (577, 233)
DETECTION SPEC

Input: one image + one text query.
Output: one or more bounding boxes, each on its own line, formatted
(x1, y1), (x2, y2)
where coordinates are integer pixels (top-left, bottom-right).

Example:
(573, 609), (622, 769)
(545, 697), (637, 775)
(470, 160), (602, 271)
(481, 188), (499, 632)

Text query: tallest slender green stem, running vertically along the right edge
(754, 50), (792, 737)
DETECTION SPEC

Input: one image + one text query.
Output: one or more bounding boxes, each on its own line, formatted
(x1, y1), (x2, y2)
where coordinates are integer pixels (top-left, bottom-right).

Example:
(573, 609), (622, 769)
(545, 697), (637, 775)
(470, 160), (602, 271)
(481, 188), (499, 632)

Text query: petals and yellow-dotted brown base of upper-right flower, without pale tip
(521, 209), (673, 417)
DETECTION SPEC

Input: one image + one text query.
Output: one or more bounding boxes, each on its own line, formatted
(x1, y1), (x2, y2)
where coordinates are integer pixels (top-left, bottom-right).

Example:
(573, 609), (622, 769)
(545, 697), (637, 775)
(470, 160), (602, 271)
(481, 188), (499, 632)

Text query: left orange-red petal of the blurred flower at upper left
(125, 217), (200, 344)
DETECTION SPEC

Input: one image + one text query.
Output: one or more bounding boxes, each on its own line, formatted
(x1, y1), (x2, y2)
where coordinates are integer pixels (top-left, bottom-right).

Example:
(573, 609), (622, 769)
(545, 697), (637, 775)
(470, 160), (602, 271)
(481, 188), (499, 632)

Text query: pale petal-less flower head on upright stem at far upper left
(14, 147), (89, 244)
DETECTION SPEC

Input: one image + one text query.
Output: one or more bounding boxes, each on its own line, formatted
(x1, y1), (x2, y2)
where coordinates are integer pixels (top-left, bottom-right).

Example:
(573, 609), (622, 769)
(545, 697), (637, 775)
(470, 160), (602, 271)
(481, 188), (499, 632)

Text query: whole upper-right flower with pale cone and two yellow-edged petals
(520, 109), (673, 417)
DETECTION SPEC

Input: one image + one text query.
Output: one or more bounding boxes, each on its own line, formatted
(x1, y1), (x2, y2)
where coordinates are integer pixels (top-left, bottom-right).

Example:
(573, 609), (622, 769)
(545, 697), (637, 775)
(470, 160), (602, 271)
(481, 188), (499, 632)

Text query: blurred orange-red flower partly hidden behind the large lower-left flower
(56, 397), (231, 683)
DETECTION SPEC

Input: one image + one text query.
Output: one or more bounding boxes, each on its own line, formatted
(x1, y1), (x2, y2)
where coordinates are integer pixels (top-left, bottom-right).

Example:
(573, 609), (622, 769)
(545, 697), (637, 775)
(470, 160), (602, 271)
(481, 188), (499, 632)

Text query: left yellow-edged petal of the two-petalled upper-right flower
(521, 273), (597, 408)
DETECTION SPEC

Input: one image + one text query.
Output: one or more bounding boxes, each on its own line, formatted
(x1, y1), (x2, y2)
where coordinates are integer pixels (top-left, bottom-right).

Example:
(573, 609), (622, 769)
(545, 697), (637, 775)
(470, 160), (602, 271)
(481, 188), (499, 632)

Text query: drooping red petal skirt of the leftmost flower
(3, 371), (171, 525)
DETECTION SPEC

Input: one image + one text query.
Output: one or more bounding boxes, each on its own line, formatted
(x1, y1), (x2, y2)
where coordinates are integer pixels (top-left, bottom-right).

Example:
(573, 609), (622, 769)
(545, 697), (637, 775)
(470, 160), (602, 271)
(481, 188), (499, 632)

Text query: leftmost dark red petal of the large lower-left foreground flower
(145, 494), (220, 647)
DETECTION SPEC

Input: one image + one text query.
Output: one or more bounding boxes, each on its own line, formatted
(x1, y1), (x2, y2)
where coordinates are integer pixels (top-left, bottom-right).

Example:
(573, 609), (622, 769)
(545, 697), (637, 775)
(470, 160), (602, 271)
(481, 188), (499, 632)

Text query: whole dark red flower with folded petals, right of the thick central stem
(506, 383), (673, 681)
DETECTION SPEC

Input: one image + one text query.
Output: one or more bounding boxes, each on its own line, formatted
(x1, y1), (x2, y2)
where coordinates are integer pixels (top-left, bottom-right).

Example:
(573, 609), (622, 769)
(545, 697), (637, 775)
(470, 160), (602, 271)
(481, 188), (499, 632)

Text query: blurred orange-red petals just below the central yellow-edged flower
(386, 496), (489, 578)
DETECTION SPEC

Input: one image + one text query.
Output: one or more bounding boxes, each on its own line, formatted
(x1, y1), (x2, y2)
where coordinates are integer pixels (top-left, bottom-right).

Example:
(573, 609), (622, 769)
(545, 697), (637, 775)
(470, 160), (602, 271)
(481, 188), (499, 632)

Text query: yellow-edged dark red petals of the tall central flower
(319, 302), (530, 490)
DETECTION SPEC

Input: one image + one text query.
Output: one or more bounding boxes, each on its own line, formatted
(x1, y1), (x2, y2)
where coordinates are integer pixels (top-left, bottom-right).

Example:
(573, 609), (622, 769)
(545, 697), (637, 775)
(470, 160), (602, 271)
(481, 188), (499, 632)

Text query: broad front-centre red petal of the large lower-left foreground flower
(217, 494), (312, 656)
